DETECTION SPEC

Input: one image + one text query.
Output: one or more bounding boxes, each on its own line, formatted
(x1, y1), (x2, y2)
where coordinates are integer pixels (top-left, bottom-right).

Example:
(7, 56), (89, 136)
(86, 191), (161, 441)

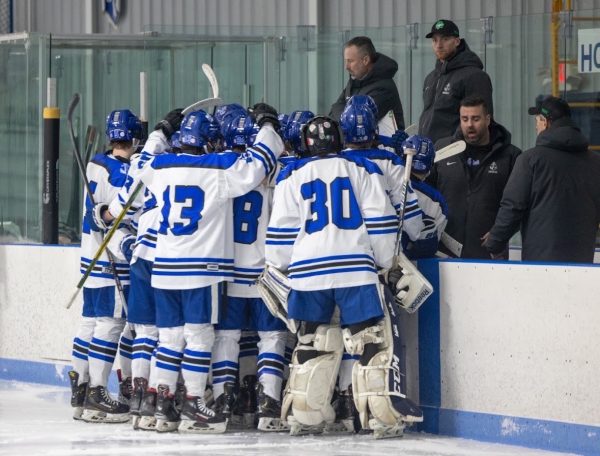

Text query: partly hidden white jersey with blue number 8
(227, 182), (273, 298)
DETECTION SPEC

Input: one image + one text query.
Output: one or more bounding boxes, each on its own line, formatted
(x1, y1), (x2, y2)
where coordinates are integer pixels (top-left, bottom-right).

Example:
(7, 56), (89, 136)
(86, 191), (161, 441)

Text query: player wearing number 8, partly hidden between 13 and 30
(212, 112), (287, 431)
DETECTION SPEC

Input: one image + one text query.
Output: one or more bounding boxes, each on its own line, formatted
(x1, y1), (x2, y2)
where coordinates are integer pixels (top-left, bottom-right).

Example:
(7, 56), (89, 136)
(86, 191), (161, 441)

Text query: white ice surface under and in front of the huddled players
(0, 381), (566, 456)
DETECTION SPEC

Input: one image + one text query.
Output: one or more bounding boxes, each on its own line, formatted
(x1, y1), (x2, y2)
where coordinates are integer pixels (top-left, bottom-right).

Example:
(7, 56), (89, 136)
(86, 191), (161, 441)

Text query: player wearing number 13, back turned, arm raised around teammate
(100, 104), (283, 433)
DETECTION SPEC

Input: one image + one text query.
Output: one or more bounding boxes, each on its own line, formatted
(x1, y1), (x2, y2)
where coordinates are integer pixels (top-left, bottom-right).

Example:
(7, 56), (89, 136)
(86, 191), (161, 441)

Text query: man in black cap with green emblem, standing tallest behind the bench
(419, 19), (493, 143)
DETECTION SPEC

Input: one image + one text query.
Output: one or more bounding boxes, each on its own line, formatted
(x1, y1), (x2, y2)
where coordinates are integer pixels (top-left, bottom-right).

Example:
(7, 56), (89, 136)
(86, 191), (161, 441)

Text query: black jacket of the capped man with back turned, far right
(486, 118), (600, 263)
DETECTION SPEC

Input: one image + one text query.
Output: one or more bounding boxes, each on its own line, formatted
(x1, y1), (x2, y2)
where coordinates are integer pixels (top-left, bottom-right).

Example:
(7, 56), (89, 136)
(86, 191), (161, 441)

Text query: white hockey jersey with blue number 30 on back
(266, 154), (398, 291)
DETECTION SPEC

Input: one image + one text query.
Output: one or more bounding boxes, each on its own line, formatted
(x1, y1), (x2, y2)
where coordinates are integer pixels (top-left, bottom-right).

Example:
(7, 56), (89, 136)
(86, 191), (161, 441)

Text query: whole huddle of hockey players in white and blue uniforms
(69, 95), (446, 438)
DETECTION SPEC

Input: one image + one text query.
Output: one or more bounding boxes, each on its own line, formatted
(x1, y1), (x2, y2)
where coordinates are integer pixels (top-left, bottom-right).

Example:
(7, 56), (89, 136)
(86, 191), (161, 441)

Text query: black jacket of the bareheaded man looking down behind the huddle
(329, 52), (404, 130)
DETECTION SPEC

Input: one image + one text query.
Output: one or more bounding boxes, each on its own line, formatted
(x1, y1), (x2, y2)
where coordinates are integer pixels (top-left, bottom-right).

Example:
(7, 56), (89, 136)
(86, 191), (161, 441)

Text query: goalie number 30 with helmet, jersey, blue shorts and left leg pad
(266, 117), (397, 435)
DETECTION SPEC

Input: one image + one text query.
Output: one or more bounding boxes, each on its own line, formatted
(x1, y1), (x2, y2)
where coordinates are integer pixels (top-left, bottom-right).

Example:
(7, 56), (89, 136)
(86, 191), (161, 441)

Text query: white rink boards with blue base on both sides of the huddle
(0, 245), (600, 454)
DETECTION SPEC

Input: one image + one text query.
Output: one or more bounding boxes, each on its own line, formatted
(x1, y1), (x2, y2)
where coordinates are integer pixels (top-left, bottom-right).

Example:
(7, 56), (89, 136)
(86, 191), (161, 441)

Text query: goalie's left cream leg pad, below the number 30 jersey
(281, 325), (343, 426)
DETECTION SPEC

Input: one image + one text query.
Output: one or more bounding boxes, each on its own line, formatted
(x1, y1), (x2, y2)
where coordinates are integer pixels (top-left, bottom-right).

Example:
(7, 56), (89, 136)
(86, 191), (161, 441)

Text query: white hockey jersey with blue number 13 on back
(132, 124), (283, 290)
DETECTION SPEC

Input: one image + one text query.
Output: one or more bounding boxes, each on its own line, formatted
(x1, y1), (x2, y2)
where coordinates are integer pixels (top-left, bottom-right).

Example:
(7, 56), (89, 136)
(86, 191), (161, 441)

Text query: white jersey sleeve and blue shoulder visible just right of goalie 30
(342, 149), (424, 240)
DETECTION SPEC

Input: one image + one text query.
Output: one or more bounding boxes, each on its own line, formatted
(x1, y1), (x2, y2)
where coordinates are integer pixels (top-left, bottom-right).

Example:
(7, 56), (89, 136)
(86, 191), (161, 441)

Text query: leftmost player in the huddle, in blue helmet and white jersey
(69, 109), (142, 422)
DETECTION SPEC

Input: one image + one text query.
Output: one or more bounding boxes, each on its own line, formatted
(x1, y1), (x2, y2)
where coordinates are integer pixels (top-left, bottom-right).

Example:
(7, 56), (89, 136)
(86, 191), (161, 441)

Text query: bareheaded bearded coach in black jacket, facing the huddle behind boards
(428, 96), (521, 259)
